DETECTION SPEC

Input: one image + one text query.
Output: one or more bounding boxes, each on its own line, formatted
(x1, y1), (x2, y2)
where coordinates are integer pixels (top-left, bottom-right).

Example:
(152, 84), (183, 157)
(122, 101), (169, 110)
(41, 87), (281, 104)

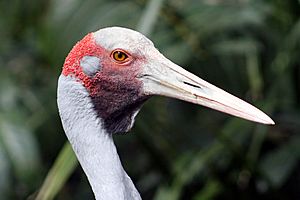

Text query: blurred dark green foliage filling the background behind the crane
(0, 0), (300, 200)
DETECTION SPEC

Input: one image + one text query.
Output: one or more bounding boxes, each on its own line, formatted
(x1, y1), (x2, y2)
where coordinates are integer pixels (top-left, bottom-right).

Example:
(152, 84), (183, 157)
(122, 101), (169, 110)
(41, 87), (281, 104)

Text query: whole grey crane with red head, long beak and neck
(57, 27), (274, 200)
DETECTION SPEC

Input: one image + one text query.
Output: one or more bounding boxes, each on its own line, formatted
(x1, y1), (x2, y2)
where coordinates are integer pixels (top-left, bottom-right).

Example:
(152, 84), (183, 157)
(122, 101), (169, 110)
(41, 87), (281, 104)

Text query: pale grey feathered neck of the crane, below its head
(57, 75), (141, 200)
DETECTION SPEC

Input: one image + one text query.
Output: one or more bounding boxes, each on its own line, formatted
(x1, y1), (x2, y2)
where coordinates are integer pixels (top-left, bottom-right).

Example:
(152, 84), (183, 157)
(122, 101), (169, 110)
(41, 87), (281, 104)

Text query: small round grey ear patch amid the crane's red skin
(80, 56), (101, 76)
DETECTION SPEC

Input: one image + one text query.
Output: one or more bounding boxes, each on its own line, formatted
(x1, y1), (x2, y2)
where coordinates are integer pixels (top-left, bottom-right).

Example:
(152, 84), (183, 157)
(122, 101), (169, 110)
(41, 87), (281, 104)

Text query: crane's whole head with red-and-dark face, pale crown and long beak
(62, 27), (274, 133)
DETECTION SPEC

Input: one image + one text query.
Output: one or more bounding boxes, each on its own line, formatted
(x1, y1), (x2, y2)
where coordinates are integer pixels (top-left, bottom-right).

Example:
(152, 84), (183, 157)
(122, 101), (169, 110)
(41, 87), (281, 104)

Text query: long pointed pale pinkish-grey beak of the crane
(139, 52), (275, 124)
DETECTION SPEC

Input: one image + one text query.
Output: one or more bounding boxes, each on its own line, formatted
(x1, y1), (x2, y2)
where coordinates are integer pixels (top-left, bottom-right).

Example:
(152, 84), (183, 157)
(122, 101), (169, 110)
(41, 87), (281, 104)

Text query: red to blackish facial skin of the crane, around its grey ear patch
(62, 33), (148, 133)
